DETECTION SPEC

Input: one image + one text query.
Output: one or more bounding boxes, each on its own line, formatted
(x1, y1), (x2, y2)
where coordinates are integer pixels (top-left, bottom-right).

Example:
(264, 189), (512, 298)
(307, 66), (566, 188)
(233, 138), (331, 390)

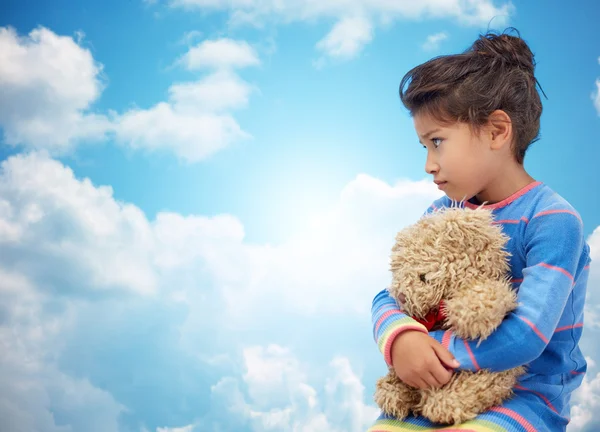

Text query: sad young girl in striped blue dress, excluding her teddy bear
(369, 28), (590, 432)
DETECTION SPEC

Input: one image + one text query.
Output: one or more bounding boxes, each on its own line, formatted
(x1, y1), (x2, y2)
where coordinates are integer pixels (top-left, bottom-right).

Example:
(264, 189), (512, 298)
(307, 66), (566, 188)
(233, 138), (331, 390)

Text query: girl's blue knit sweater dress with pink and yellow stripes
(369, 182), (590, 432)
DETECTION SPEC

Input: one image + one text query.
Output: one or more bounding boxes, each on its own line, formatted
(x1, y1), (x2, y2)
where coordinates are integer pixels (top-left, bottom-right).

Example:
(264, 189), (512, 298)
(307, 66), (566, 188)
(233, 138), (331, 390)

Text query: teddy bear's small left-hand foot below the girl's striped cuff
(374, 370), (420, 420)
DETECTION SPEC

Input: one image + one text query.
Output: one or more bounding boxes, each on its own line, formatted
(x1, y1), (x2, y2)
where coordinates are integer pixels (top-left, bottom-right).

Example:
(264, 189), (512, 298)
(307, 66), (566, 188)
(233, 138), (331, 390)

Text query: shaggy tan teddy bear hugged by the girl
(375, 206), (525, 425)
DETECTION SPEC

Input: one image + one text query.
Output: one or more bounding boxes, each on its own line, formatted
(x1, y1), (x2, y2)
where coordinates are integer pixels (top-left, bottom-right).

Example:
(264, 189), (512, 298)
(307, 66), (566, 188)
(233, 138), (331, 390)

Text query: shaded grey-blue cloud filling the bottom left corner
(0, 264), (125, 432)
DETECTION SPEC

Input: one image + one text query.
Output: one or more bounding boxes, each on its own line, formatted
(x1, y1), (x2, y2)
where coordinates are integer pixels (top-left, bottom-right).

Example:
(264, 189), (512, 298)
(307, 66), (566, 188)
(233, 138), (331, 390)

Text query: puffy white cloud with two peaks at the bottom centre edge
(204, 345), (379, 432)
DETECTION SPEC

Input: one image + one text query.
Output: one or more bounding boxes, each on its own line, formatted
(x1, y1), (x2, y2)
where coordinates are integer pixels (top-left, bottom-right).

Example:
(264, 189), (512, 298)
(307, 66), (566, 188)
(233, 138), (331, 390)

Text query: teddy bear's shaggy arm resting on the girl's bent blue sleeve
(445, 280), (517, 340)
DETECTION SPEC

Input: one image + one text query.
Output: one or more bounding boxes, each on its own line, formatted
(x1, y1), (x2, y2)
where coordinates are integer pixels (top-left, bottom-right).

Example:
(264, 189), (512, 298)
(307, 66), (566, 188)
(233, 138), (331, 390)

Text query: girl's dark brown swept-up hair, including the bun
(400, 28), (545, 164)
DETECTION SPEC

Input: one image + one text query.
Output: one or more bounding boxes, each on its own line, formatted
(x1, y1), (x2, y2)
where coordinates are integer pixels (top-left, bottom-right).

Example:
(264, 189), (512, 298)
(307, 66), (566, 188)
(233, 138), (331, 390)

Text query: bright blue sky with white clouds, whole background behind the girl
(0, 0), (600, 432)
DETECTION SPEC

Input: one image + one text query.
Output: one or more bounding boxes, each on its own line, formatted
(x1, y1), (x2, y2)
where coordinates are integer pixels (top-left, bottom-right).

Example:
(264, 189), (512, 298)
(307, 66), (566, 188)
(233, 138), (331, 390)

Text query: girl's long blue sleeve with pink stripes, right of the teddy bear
(430, 210), (589, 371)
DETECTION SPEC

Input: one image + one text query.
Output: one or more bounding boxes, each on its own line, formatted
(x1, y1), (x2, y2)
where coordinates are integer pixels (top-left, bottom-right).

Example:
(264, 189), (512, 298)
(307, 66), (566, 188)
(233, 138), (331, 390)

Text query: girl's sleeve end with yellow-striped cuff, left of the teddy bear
(371, 289), (428, 366)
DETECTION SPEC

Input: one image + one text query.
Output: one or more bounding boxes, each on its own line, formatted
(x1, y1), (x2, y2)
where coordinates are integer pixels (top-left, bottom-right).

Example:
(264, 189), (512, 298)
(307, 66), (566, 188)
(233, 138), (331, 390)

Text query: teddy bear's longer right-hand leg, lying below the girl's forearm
(416, 368), (524, 424)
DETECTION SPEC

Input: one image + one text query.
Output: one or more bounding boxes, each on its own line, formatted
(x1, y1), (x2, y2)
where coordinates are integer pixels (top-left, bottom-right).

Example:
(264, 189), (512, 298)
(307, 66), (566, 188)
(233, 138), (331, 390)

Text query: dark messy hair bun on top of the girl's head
(470, 29), (535, 75)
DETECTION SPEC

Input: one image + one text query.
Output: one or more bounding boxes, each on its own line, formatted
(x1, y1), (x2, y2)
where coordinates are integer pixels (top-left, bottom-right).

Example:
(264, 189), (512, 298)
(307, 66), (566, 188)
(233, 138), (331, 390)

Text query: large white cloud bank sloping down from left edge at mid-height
(0, 148), (254, 294)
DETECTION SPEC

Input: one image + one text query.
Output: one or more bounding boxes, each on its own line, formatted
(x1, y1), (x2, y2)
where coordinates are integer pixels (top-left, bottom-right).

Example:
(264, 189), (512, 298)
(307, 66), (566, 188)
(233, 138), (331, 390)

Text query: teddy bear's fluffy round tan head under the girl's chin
(389, 207), (509, 319)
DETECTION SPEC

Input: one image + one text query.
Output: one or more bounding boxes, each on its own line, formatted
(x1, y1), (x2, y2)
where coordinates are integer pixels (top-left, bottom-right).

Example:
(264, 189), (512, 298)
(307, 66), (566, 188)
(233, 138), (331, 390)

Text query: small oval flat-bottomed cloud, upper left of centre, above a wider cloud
(180, 39), (260, 70)
